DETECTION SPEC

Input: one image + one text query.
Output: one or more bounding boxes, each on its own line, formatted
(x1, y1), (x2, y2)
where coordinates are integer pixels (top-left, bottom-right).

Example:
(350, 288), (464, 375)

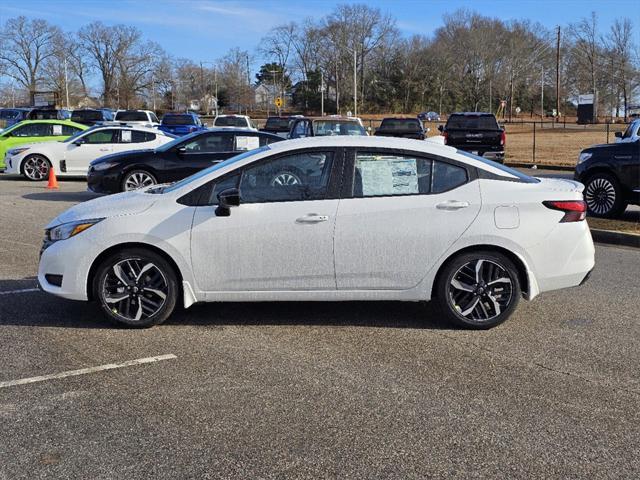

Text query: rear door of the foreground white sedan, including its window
(335, 149), (481, 290)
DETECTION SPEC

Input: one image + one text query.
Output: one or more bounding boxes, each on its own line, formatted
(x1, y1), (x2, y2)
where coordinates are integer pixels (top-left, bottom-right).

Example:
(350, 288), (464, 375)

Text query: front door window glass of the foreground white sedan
(240, 152), (333, 203)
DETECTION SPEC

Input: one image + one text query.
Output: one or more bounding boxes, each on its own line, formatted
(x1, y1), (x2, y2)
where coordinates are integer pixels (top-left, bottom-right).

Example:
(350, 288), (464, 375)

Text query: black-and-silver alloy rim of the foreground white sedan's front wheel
(100, 258), (169, 322)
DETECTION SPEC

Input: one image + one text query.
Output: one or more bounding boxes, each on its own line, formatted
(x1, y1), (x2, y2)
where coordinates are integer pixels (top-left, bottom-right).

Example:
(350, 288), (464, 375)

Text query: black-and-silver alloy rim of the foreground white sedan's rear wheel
(449, 258), (513, 322)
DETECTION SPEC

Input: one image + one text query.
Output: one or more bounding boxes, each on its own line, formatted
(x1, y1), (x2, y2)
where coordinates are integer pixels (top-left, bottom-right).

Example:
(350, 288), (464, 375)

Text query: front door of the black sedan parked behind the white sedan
(164, 132), (234, 179)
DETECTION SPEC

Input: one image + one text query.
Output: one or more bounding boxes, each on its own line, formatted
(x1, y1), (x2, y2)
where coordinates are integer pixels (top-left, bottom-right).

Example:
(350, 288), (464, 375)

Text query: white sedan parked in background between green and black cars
(5, 125), (175, 181)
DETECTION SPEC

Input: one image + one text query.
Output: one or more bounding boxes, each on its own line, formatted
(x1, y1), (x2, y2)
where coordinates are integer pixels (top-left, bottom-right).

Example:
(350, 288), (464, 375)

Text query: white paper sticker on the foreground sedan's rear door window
(357, 156), (419, 196)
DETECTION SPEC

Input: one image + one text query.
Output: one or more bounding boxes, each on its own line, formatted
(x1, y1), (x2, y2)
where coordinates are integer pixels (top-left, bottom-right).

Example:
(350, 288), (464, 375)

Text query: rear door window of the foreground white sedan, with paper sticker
(353, 152), (432, 198)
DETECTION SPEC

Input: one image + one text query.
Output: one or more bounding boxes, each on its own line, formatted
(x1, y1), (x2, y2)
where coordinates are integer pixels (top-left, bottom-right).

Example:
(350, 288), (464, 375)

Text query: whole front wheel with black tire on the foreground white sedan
(93, 248), (179, 328)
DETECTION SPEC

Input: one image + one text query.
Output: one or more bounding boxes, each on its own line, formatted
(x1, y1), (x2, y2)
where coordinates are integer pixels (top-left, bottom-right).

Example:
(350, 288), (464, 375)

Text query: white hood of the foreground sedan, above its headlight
(46, 191), (158, 228)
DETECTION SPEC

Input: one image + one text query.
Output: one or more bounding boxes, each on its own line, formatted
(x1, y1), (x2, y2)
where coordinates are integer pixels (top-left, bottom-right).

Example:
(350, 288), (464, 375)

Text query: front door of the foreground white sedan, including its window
(191, 149), (341, 292)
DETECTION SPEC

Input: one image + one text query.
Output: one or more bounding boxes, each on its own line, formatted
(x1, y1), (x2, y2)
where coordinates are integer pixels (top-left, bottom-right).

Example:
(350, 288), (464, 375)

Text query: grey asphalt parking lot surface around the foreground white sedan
(0, 176), (640, 480)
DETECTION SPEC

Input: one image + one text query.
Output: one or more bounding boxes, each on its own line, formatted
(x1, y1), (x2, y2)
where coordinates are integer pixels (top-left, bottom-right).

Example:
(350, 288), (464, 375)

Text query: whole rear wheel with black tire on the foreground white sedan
(434, 250), (521, 329)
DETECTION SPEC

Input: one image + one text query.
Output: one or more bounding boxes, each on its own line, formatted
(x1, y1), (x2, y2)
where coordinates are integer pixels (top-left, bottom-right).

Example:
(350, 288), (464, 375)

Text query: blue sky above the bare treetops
(0, 0), (640, 70)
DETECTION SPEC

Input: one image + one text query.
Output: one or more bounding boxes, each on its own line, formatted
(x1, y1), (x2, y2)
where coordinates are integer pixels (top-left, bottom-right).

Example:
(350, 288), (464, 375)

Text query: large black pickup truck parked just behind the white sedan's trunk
(438, 112), (507, 163)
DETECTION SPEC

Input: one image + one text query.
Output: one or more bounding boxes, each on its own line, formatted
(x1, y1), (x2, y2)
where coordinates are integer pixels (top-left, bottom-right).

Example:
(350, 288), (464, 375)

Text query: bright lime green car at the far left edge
(0, 120), (89, 170)
